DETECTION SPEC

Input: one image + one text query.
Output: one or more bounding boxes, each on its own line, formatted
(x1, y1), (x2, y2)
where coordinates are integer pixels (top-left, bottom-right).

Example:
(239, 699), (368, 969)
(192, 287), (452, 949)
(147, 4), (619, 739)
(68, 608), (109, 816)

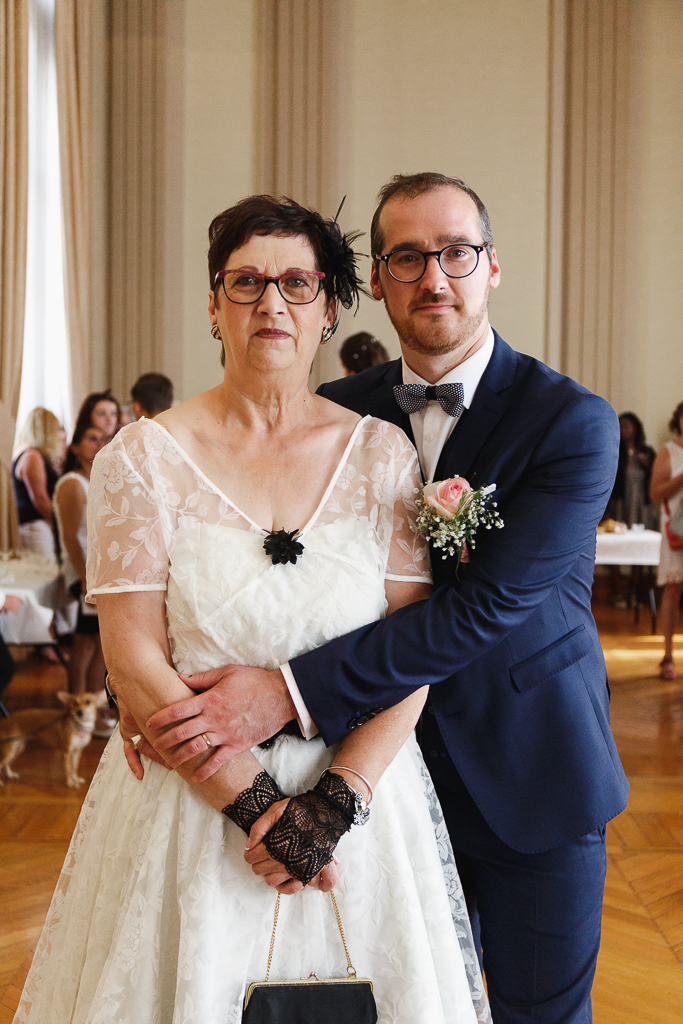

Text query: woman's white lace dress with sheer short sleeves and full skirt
(14, 417), (489, 1024)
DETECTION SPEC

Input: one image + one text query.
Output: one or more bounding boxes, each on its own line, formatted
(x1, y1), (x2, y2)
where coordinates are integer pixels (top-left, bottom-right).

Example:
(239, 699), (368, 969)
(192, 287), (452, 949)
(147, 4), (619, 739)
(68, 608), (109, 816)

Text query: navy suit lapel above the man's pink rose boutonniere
(434, 331), (517, 487)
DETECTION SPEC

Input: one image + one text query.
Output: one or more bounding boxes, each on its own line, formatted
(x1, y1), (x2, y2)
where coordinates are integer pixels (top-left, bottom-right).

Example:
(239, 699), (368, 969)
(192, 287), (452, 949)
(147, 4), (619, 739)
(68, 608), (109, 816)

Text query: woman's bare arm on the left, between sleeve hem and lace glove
(97, 592), (270, 810)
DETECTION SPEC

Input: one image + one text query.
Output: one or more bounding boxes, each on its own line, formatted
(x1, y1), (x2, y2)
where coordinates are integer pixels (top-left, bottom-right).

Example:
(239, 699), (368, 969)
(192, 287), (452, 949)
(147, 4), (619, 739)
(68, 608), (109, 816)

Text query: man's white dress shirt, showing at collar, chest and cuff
(280, 328), (494, 739)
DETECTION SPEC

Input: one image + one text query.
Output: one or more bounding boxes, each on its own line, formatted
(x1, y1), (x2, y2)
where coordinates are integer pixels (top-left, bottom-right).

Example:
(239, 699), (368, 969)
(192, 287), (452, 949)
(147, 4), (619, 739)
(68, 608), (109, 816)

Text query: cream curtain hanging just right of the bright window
(54, 0), (92, 415)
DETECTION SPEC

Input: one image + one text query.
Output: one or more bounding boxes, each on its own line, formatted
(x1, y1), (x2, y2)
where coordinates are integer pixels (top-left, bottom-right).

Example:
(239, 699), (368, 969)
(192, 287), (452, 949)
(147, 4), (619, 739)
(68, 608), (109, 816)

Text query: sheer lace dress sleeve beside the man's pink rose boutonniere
(365, 420), (432, 583)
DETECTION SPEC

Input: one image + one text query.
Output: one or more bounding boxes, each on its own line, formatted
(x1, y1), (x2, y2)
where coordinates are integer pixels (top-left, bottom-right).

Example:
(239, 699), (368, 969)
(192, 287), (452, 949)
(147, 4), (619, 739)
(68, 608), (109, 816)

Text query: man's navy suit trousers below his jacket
(421, 707), (606, 1024)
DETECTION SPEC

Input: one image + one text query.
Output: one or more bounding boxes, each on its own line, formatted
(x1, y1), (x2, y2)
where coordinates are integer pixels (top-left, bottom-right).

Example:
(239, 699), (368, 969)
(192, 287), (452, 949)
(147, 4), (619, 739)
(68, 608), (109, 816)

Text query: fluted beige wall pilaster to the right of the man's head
(547, 0), (631, 408)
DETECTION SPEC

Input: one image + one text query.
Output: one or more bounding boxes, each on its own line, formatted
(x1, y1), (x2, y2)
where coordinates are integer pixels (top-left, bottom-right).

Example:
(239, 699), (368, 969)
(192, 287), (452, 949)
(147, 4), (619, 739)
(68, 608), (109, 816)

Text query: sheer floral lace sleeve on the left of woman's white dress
(86, 435), (169, 604)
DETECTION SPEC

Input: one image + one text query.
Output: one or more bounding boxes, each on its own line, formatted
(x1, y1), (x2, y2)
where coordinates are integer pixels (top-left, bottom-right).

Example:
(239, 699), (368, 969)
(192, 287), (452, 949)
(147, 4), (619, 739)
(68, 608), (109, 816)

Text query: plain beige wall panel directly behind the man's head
(343, 0), (549, 372)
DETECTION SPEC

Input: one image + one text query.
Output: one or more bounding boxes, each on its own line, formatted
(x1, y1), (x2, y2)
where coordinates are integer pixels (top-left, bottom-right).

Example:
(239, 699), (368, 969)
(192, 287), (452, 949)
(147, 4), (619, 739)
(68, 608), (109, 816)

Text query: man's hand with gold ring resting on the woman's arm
(147, 665), (297, 782)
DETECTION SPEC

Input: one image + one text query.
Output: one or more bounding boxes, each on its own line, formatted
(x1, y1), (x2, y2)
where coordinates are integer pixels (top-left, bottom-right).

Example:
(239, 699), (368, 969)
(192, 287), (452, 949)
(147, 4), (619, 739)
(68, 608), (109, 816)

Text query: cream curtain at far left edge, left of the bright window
(0, 0), (29, 553)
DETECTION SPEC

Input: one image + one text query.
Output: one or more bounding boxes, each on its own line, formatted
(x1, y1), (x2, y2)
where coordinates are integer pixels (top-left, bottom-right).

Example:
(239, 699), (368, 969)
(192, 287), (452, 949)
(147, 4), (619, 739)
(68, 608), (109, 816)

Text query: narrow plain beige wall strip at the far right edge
(626, 0), (683, 447)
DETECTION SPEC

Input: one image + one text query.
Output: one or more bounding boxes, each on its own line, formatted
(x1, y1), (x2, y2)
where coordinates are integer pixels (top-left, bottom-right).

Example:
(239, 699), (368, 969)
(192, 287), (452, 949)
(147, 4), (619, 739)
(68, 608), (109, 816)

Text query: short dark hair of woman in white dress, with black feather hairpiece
(209, 196), (362, 366)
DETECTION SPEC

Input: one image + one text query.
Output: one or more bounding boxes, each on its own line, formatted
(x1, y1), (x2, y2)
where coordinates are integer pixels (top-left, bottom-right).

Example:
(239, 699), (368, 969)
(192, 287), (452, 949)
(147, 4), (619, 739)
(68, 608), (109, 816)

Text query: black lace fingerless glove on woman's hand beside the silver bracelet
(263, 772), (356, 886)
